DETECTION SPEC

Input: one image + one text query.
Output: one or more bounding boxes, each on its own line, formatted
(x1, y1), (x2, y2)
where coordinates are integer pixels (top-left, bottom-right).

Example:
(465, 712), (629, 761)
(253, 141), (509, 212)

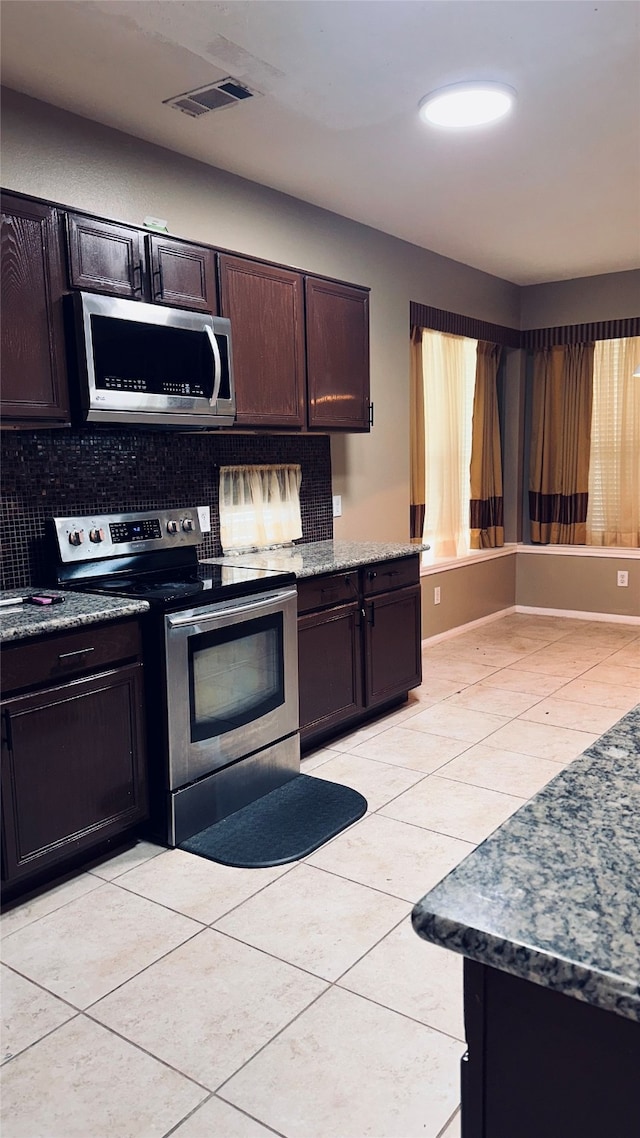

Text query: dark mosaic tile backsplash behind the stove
(0, 427), (334, 588)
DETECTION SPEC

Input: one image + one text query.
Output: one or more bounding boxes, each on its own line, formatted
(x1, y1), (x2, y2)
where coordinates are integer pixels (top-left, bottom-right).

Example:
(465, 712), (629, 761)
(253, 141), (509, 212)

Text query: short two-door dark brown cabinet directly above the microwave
(66, 214), (218, 314)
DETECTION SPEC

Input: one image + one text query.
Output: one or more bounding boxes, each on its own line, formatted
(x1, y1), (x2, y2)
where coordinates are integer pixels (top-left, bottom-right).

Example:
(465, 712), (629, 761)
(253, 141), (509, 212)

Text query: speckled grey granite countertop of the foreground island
(412, 704), (640, 1021)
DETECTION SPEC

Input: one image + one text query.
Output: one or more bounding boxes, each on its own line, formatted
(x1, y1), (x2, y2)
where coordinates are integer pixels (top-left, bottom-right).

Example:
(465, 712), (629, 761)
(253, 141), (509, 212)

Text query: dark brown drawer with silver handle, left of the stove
(2, 620), (140, 693)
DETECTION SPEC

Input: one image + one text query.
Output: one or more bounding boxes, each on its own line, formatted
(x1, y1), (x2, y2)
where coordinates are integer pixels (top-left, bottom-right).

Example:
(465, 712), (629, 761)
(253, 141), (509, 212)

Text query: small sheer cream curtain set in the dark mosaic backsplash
(220, 465), (302, 553)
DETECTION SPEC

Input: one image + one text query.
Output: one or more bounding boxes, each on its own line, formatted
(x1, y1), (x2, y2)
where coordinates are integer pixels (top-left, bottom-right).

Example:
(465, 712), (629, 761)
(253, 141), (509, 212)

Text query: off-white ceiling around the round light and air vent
(1, 0), (640, 285)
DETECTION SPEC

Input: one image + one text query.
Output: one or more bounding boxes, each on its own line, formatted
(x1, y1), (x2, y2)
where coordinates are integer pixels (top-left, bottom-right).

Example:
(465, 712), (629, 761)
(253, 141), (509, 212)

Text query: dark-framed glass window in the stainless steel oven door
(189, 612), (285, 743)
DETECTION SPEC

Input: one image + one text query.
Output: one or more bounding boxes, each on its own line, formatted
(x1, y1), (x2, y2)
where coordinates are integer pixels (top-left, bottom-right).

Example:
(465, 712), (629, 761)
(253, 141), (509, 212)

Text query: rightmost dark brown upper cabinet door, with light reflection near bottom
(305, 277), (369, 431)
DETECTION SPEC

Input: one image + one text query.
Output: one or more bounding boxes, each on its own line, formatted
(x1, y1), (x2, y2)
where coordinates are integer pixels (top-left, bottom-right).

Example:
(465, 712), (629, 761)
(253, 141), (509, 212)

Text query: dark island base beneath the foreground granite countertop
(461, 959), (640, 1138)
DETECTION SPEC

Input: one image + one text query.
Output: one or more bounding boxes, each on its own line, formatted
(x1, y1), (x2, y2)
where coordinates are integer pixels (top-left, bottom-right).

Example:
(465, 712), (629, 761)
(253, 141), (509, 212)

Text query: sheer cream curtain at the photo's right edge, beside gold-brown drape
(586, 336), (640, 549)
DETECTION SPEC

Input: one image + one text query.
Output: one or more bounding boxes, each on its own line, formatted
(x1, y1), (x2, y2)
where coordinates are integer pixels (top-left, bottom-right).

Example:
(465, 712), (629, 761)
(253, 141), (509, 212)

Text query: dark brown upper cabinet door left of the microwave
(0, 195), (69, 426)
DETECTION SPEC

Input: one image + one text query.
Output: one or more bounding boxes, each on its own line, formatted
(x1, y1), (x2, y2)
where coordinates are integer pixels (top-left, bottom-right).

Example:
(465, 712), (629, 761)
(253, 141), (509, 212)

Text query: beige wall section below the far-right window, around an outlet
(516, 550), (640, 619)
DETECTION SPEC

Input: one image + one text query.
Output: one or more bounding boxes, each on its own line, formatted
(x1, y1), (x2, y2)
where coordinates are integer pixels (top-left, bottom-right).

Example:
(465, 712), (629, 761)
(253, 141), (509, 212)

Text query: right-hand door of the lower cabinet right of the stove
(364, 585), (422, 707)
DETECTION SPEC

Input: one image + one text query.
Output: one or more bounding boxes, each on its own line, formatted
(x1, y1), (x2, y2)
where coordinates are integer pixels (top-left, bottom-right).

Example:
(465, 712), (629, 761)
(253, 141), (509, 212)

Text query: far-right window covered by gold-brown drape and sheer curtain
(528, 337), (640, 549)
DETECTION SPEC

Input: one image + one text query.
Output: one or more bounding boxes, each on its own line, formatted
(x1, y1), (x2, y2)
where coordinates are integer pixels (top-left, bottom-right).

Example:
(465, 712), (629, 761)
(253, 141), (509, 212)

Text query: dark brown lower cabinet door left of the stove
(2, 663), (147, 881)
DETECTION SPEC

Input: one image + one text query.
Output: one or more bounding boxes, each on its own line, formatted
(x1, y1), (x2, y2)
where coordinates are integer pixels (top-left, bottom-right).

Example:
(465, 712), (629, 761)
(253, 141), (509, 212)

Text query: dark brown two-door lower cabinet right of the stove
(298, 555), (421, 749)
